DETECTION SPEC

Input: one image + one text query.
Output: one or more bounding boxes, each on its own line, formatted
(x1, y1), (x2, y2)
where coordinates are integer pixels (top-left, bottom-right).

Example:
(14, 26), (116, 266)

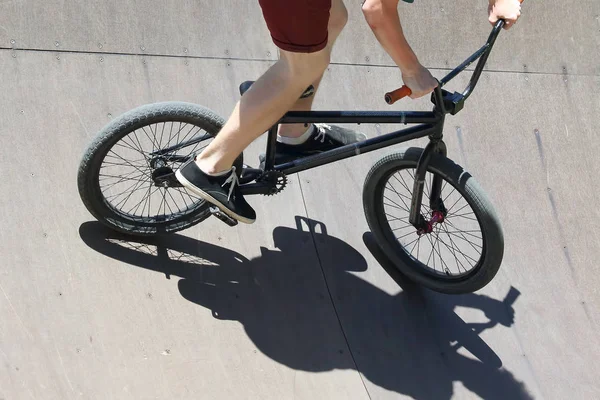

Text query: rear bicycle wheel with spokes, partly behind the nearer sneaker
(77, 102), (243, 236)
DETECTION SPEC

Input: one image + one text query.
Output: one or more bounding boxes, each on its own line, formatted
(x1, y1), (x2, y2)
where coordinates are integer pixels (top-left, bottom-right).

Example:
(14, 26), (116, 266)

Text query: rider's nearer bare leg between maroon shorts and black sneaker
(197, 47), (330, 174)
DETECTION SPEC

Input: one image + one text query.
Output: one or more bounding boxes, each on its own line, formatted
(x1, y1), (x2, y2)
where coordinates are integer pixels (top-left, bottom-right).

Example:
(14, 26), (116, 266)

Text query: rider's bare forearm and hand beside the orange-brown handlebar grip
(362, 0), (437, 98)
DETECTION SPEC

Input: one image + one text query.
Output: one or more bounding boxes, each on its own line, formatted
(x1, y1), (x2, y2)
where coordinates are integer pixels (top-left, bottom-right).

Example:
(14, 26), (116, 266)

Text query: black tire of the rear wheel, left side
(77, 101), (243, 236)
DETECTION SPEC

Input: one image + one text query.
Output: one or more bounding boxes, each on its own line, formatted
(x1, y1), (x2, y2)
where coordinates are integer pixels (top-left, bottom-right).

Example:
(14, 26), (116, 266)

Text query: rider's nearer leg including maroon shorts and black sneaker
(175, 0), (338, 223)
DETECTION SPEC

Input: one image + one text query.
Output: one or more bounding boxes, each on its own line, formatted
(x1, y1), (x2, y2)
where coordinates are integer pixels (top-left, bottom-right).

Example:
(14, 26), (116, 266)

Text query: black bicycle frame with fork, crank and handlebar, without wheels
(240, 20), (504, 229)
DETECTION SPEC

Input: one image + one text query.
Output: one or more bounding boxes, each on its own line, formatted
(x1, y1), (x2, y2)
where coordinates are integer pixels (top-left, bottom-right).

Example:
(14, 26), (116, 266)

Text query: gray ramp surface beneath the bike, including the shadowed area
(0, 0), (600, 399)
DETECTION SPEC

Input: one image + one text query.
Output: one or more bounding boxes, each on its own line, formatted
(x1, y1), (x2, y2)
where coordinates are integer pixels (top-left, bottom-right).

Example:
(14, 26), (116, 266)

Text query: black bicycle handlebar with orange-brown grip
(384, 0), (524, 105)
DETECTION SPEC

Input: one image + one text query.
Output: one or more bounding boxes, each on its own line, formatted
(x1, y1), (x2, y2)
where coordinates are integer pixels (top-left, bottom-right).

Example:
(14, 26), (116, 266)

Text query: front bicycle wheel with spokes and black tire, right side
(363, 148), (504, 294)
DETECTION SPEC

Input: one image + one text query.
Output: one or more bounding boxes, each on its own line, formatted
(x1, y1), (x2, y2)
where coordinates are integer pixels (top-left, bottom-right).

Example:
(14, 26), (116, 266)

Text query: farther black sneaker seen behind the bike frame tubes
(260, 124), (367, 165)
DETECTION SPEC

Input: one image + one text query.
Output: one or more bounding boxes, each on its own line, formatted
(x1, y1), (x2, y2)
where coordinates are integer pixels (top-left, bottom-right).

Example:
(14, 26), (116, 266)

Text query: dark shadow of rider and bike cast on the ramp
(80, 217), (531, 399)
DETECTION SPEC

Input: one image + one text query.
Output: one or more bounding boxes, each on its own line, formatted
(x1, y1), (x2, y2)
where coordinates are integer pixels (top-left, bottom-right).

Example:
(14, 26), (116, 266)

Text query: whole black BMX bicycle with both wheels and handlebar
(78, 20), (520, 294)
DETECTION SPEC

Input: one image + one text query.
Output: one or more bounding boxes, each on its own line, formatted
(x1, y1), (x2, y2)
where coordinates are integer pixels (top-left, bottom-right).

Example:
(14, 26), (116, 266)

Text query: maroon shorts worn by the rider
(258, 0), (331, 53)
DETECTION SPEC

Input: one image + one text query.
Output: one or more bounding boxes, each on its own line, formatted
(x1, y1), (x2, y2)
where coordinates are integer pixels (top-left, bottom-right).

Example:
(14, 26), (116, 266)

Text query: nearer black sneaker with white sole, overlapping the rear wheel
(175, 158), (256, 224)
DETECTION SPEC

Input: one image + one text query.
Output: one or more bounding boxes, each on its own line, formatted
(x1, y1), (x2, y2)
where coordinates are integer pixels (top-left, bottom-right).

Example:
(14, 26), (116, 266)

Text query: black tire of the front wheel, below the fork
(363, 147), (504, 294)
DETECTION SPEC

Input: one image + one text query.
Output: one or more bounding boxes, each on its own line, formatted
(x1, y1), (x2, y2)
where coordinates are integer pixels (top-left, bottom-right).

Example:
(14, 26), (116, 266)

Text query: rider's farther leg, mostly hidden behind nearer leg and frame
(279, 0), (348, 138)
